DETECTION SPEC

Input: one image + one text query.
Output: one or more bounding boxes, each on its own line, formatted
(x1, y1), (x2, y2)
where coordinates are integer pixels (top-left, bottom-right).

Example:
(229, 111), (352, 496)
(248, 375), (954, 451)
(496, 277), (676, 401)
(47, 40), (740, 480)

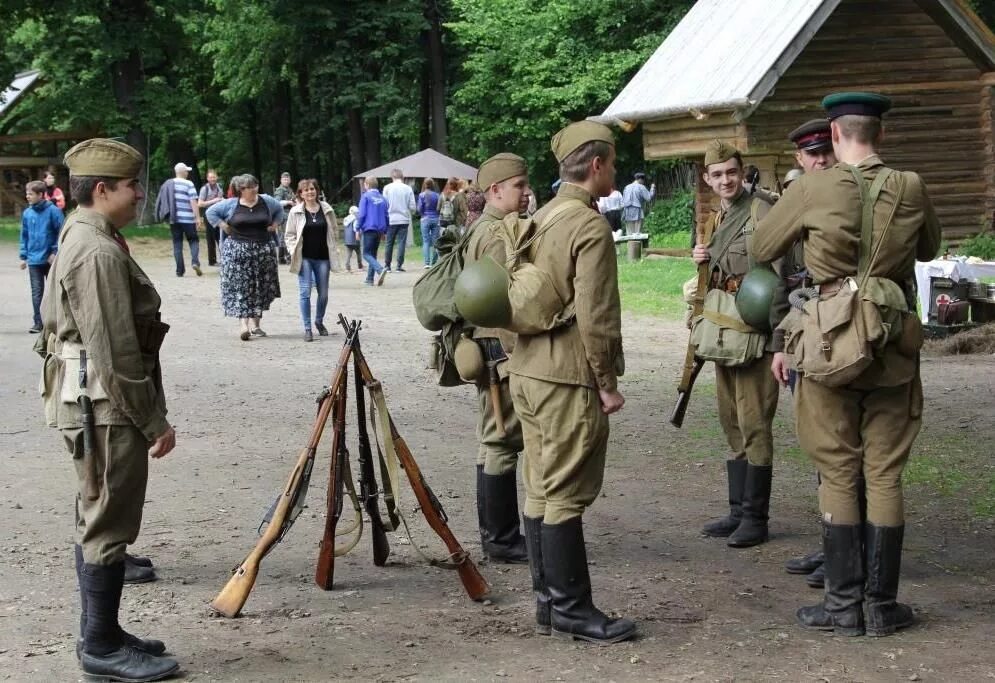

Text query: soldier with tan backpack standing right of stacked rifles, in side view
(509, 121), (636, 643)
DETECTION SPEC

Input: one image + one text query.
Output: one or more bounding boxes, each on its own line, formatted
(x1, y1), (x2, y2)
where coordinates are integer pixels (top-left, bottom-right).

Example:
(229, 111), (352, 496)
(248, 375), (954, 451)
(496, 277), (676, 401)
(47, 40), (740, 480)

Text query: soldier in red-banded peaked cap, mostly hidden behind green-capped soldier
(770, 119), (836, 588)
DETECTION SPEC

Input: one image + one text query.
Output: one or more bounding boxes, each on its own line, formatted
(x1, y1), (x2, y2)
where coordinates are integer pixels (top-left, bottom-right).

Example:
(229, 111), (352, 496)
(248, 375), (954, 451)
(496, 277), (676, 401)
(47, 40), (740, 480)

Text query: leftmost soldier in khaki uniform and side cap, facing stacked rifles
(36, 139), (179, 681)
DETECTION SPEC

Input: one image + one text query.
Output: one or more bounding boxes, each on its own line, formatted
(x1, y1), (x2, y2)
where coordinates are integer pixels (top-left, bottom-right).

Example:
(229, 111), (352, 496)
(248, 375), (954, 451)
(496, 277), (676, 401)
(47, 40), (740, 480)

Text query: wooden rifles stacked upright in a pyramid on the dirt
(211, 315), (488, 618)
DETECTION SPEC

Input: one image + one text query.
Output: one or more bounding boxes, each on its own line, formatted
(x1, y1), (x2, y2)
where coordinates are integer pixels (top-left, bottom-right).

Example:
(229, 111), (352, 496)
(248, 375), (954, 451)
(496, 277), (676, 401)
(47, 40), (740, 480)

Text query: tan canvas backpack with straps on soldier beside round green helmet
(499, 199), (586, 335)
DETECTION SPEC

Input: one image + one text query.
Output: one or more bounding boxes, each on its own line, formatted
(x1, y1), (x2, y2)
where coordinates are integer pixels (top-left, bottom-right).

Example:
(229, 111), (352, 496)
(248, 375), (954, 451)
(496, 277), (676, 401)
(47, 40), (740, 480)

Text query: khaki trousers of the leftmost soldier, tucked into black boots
(62, 425), (150, 565)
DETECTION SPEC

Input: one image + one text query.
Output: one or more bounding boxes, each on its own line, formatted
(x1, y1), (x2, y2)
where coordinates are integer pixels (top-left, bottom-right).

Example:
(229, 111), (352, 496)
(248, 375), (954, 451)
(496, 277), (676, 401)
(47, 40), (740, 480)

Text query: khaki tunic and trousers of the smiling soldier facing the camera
(708, 191), (786, 467)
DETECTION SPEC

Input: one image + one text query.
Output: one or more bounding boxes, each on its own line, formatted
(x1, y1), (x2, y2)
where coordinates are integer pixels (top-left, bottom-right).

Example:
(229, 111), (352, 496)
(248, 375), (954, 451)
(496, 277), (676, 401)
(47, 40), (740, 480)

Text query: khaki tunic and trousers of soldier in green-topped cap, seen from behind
(752, 155), (940, 527)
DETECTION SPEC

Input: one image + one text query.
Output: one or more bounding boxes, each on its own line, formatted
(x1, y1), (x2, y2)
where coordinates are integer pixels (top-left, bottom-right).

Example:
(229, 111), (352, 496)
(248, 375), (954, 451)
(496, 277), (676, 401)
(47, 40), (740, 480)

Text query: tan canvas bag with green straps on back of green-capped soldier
(785, 166), (909, 387)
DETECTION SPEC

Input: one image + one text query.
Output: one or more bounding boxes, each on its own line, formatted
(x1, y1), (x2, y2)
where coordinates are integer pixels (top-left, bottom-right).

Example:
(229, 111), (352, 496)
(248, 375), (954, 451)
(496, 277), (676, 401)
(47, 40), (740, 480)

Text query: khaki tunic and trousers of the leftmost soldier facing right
(37, 208), (169, 565)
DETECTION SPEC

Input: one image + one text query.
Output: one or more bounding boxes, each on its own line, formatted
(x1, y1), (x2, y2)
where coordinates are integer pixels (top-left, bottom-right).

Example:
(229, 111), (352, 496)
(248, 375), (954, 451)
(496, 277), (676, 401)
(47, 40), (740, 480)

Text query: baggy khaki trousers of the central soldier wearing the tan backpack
(511, 375), (608, 524)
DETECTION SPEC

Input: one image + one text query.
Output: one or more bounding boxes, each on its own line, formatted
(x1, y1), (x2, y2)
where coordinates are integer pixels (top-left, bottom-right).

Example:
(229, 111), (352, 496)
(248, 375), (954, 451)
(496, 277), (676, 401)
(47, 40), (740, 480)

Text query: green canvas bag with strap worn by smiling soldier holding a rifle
(685, 200), (767, 367)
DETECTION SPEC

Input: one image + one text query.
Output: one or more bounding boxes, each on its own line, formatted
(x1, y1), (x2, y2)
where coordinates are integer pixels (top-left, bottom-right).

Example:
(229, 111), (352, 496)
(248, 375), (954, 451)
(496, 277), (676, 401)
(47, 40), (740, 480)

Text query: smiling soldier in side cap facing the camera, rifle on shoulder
(693, 140), (778, 548)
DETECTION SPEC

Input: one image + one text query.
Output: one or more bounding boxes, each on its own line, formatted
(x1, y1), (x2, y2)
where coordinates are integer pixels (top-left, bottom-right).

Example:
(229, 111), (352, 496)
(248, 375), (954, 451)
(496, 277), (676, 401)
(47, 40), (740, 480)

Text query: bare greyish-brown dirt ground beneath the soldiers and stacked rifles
(0, 245), (995, 681)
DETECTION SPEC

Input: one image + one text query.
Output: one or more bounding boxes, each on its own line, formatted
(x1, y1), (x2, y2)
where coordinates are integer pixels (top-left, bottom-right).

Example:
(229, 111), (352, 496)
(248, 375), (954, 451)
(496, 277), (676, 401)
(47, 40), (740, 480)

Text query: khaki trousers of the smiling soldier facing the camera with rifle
(715, 353), (780, 467)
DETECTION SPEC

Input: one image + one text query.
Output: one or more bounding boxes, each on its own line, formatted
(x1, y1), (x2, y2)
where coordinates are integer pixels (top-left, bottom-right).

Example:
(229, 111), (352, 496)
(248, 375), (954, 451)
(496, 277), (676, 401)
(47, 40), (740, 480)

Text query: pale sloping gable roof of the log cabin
(593, 0), (995, 124)
